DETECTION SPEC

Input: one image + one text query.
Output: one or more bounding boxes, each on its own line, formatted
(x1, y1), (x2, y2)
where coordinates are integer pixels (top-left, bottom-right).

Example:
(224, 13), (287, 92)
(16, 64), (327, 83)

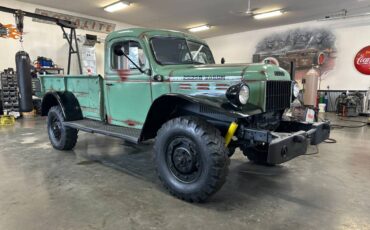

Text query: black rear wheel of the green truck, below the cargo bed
(47, 106), (78, 150)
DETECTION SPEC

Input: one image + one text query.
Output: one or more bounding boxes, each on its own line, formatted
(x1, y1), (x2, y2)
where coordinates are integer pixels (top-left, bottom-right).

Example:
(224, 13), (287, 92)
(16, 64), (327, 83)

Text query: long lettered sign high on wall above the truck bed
(33, 8), (116, 33)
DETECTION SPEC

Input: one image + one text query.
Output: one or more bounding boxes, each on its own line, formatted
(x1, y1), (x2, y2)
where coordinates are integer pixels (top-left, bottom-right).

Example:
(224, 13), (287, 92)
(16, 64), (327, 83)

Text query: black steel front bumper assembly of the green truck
(236, 121), (330, 164)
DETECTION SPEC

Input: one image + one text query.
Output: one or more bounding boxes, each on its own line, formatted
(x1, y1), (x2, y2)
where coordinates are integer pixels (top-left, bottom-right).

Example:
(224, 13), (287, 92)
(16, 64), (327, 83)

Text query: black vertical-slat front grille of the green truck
(266, 81), (292, 112)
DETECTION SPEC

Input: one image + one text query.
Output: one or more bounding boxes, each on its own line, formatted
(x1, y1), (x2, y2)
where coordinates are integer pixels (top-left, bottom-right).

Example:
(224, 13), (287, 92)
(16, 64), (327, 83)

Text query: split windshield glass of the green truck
(151, 37), (215, 65)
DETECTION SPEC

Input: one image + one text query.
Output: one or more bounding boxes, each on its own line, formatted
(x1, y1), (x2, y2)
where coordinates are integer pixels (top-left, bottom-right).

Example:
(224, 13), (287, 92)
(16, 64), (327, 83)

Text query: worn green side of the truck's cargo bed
(40, 75), (104, 121)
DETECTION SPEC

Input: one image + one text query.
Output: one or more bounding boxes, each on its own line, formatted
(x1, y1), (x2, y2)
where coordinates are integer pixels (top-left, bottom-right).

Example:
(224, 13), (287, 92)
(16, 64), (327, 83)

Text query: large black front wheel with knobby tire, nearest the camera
(154, 117), (230, 202)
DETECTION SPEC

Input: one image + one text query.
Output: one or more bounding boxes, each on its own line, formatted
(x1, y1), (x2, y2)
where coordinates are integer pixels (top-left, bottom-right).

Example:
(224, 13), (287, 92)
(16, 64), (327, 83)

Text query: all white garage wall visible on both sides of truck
(0, 0), (370, 90)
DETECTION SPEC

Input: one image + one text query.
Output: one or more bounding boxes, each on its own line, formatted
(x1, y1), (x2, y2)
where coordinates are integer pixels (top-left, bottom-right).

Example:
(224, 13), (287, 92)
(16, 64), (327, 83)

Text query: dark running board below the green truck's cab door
(63, 119), (141, 144)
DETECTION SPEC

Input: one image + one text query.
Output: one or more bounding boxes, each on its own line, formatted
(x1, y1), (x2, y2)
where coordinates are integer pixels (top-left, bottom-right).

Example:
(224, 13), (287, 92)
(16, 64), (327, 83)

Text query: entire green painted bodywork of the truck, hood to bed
(40, 28), (291, 128)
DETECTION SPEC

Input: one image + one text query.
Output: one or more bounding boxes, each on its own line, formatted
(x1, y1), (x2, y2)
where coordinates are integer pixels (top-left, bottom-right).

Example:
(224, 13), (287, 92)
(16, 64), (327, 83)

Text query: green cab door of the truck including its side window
(104, 38), (152, 129)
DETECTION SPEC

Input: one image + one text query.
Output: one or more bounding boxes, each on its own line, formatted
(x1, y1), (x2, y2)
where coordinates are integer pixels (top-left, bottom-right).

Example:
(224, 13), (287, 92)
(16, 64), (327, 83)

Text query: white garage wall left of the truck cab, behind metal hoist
(0, 0), (134, 74)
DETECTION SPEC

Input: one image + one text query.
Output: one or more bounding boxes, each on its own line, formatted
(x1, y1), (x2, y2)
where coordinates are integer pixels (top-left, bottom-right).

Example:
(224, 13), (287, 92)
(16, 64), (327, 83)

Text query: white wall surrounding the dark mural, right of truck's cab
(206, 17), (370, 90)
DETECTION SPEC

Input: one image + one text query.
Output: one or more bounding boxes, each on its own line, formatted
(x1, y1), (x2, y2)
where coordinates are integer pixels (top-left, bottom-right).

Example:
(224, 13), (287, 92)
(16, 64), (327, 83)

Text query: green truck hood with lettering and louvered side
(157, 64), (290, 115)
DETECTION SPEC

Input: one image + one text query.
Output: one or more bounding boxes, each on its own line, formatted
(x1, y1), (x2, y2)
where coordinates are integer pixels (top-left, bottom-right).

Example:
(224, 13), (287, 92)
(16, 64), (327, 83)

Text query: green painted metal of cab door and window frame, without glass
(104, 36), (152, 129)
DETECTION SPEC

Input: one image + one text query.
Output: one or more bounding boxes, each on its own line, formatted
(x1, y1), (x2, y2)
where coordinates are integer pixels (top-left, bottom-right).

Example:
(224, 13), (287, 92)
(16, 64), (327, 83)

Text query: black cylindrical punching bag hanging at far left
(15, 51), (33, 112)
